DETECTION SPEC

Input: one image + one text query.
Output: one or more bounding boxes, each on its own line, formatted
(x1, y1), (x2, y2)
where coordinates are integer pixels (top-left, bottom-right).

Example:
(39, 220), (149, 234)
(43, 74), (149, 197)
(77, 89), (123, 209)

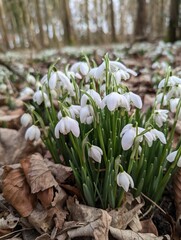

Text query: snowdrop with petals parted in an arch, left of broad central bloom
(80, 89), (101, 107)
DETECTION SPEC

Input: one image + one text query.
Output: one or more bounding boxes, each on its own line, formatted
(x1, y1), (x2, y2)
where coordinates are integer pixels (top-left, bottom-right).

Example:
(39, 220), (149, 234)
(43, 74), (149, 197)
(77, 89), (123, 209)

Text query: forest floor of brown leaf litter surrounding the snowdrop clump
(0, 42), (181, 240)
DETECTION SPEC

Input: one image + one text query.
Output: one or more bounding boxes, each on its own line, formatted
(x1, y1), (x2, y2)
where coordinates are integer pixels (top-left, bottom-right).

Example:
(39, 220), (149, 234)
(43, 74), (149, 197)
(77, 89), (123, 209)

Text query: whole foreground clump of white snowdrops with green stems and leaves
(21, 55), (181, 209)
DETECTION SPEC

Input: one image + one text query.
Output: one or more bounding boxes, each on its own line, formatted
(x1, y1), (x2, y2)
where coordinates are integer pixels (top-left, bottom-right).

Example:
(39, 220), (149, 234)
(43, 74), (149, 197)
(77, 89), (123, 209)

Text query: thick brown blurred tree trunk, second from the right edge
(134, 0), (146, 39)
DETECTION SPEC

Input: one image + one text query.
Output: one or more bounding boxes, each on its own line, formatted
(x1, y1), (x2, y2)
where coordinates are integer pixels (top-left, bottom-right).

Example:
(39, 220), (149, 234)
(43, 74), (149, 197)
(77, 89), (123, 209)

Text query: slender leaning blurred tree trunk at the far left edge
(0, 0), (10, 48)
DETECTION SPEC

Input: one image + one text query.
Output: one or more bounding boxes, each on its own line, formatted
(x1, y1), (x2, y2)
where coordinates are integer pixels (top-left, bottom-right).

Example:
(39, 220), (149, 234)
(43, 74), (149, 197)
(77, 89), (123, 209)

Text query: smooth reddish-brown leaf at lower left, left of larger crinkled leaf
(3, 167), (36, 217)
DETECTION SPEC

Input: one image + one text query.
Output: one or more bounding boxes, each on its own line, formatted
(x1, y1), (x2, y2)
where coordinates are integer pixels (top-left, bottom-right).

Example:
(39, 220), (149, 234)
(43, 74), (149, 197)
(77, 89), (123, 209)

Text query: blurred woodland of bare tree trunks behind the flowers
(0, 0), (181, 52)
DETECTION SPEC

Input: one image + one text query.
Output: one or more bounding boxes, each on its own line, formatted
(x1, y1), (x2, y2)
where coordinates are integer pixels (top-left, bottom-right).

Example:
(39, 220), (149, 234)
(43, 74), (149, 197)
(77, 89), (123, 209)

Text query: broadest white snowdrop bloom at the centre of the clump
(102, 92), (130, 111)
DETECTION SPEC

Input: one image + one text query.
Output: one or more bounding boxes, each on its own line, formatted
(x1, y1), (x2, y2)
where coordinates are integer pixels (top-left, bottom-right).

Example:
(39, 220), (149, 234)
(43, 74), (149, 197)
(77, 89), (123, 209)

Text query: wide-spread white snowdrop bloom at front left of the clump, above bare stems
(55, 116), (80, 138)
